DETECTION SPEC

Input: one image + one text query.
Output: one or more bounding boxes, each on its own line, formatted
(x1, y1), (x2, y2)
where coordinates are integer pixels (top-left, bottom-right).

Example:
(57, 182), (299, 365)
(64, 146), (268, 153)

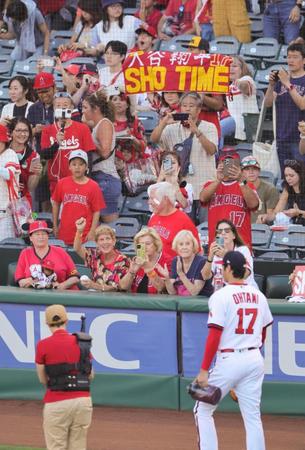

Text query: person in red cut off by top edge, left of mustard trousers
(158, 0), (197, 41)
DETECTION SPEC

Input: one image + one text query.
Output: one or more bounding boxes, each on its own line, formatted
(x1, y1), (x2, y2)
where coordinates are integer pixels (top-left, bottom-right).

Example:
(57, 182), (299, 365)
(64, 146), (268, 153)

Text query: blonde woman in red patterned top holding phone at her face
(121, 227), (167, 294)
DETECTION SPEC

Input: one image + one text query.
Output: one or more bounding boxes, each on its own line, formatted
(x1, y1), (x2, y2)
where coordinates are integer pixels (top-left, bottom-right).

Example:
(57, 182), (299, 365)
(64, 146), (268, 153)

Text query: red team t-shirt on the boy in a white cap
(52, 176), (106, 245)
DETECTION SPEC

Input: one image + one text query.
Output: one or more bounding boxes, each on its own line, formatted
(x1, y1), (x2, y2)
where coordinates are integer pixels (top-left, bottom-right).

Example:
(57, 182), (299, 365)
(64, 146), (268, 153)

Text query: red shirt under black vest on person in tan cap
(35, 329), (90, 403)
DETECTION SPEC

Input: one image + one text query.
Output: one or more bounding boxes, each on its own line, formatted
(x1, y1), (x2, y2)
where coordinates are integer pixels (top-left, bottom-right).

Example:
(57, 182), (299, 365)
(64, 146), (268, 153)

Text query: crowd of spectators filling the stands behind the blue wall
(0, 0), (305, 296)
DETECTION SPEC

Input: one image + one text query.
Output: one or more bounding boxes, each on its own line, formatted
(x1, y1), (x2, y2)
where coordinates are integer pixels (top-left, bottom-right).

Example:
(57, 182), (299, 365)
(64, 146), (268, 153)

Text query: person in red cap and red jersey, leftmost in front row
(15, 220), (79, 290)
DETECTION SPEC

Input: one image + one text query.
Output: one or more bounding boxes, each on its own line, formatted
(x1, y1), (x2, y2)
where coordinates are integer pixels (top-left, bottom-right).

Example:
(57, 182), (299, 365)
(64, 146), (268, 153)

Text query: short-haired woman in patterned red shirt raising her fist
(73, 217), (130, 292)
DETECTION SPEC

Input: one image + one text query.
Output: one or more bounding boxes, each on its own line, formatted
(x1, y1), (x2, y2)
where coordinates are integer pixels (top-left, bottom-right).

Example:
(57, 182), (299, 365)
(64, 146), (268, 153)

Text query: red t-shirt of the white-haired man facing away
(148, 209), (201, 260)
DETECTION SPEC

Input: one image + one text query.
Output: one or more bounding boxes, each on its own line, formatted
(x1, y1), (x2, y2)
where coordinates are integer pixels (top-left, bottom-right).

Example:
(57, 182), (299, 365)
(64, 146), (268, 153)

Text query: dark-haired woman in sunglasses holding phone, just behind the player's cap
(201, 219), (258, 290)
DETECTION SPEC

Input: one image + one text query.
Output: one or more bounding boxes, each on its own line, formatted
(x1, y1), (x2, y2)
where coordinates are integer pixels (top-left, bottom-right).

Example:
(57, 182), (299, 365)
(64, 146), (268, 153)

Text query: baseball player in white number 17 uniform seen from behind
(194, 251), (273, 450)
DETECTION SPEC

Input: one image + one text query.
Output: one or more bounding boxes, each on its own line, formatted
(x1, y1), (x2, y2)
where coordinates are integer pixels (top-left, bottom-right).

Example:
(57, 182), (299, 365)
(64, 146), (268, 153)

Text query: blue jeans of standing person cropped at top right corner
(263, 0), (301, 44)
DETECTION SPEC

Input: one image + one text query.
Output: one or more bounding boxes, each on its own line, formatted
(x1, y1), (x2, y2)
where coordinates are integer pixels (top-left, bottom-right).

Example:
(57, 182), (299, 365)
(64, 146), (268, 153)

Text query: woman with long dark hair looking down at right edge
(262, 159), (305, 225)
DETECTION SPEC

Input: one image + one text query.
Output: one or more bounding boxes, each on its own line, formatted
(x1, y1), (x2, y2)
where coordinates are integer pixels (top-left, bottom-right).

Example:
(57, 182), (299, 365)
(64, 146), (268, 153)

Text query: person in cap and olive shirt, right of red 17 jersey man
(241, 155), (279, 223)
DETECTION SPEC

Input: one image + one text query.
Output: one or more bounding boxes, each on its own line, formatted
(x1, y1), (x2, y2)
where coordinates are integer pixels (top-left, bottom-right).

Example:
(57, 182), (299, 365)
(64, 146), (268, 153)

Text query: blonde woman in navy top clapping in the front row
(157, 230), (213, 296)
